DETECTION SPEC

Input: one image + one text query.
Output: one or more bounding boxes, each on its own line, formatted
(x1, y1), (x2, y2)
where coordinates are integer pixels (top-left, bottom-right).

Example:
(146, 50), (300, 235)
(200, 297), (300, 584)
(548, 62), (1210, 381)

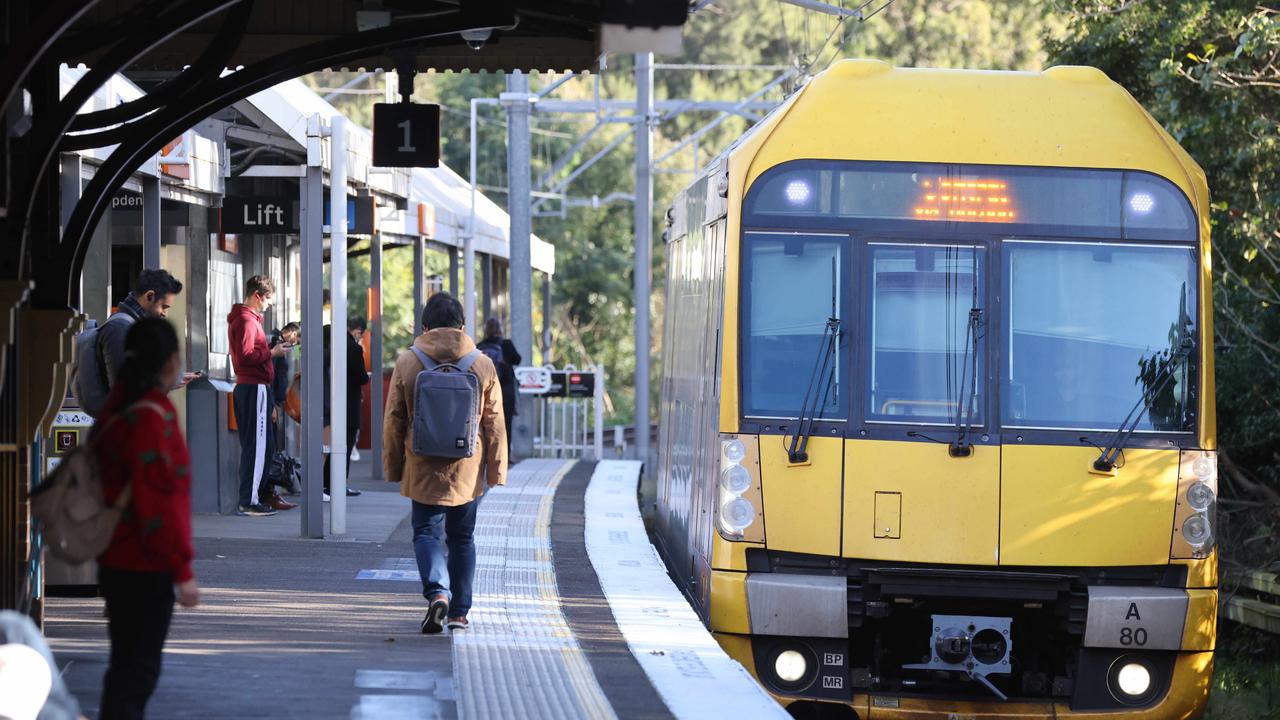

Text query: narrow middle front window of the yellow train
(867, 243), (987, 425)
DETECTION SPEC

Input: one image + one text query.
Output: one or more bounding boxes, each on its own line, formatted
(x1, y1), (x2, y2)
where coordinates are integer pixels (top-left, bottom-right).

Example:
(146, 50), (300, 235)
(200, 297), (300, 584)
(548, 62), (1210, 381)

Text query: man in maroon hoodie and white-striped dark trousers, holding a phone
(227, 275), (294, 516)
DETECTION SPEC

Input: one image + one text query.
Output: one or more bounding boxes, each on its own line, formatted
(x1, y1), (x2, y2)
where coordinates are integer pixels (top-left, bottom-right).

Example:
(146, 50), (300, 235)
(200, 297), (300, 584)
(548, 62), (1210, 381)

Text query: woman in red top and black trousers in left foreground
(93, 318), (200, 720)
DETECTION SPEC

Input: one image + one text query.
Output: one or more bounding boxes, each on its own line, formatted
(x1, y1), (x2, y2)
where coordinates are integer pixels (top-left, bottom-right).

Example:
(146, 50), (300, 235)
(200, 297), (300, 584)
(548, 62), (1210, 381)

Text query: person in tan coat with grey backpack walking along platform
(383, 292), (507, 634)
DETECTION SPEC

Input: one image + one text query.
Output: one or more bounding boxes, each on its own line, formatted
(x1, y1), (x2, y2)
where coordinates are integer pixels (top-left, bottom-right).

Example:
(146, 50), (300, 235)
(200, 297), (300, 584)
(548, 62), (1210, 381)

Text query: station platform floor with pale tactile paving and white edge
(45, 460), (787, 720)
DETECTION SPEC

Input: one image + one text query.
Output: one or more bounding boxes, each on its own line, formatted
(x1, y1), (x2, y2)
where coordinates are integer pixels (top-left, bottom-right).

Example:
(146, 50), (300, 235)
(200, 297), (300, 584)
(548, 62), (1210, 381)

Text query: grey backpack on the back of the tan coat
(410, 347), (480, 459)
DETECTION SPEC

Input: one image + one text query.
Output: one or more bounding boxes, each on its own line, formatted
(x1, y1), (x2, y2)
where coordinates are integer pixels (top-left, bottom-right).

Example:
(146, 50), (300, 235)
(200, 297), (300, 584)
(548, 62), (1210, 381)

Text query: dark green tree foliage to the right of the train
(1050, 0), (1280, 565)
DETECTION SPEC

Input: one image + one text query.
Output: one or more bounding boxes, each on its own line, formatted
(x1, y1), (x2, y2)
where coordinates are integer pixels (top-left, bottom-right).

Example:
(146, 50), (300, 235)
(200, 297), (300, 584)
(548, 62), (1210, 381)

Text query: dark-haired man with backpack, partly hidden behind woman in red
(72, 268), (197, 418)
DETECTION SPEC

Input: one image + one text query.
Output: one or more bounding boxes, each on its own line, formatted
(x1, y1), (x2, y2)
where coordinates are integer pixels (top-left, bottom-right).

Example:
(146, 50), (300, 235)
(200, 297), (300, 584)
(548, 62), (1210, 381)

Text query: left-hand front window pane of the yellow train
(742, 232), (854, 421)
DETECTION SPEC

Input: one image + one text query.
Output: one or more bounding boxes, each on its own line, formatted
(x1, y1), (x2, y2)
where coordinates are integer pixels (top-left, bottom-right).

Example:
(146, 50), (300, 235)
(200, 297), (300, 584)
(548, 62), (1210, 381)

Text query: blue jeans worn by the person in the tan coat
(412, 497), (480, 618)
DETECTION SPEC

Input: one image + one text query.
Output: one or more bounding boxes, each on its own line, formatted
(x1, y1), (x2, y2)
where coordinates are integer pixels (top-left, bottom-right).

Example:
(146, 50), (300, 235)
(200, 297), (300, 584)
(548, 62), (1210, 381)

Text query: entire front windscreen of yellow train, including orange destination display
(741, 161), (1198, 433)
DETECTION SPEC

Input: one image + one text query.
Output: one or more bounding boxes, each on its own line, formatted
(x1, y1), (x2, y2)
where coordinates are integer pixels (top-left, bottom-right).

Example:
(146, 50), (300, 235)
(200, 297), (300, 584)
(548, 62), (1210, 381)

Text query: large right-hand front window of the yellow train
(1002, 241), (1197, 432)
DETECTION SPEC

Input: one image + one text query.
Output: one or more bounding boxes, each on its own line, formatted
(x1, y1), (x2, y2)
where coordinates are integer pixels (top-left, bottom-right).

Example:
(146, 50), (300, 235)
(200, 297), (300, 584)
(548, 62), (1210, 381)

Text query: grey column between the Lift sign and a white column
(300, 115), (324, 538)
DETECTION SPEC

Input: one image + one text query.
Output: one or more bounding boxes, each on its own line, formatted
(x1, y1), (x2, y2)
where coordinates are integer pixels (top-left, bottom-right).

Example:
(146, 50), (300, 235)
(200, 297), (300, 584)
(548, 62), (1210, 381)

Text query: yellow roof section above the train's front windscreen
(727, 60), (1208, 217)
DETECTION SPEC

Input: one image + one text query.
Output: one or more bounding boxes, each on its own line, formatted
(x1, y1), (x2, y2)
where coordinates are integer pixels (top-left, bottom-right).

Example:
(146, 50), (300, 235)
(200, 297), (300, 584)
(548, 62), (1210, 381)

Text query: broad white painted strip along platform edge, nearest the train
(585, 460), (790, 720)
